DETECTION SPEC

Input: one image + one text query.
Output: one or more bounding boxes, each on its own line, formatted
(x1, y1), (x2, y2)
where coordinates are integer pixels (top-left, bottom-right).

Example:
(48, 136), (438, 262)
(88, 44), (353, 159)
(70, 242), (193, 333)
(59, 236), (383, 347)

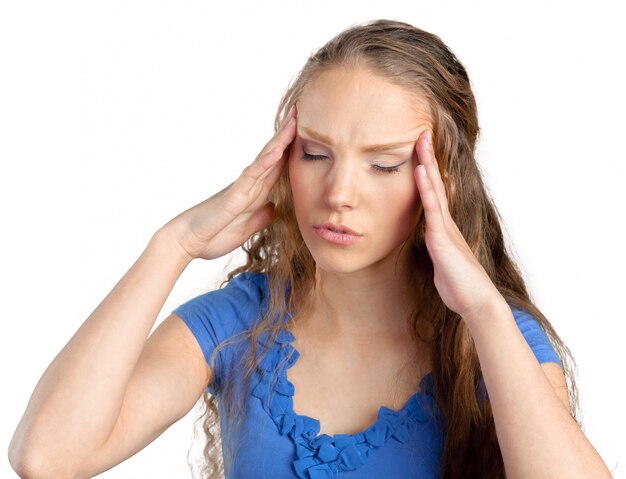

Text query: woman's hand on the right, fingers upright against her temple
(414, 130), (504, 319)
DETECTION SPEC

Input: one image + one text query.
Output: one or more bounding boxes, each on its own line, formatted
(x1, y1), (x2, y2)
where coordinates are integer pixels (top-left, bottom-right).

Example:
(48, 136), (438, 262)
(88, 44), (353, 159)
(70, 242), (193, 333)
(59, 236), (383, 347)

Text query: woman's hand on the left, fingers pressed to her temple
(161, 106), (297, 260)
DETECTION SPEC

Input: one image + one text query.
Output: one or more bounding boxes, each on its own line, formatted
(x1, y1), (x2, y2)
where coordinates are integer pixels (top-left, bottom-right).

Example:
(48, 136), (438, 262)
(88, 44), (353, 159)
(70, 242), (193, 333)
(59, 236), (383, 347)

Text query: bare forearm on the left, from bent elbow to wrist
(10, 230), (190, 472)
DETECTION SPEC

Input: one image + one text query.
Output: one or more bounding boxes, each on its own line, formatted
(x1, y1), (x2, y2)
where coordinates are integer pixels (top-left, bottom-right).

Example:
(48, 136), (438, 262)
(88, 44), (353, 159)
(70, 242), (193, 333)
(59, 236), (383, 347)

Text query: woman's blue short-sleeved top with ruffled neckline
(172, 272), (561, 479)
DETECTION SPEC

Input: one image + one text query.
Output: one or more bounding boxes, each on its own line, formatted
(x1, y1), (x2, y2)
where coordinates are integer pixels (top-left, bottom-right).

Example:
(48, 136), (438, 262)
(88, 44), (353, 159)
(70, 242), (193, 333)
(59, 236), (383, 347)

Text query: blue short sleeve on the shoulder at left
(172, 272), (266, 394)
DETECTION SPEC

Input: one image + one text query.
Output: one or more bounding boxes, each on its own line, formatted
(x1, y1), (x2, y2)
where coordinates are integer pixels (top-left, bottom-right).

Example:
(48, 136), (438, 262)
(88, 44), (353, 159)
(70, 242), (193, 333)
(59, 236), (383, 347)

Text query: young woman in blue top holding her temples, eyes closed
(10, 20), (611, 479)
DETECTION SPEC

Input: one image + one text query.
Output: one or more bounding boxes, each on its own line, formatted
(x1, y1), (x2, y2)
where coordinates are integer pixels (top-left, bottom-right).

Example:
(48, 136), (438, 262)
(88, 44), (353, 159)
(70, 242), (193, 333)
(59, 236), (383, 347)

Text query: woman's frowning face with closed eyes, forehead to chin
(289, 68), (432, 273)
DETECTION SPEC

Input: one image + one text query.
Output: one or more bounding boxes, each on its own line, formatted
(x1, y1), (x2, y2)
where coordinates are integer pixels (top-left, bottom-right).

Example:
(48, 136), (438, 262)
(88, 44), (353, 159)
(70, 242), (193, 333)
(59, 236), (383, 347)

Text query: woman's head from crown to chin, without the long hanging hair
(272, 20), (478, 279)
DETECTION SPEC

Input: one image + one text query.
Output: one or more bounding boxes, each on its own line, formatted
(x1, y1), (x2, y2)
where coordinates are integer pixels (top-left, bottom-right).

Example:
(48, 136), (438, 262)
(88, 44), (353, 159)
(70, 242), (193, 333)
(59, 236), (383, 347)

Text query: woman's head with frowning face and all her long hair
(193, 20), (578, 478)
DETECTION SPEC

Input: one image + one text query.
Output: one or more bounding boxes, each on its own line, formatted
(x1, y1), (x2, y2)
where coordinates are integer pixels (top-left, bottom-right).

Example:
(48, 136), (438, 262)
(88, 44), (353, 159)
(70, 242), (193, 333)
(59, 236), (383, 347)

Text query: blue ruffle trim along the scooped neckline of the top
(252, 329), (439, 479)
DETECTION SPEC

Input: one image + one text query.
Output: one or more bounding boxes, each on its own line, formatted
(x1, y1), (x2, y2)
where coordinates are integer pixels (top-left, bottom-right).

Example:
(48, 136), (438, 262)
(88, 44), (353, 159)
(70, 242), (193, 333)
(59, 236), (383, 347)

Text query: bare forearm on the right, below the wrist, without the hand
(463, 300), (611, 478)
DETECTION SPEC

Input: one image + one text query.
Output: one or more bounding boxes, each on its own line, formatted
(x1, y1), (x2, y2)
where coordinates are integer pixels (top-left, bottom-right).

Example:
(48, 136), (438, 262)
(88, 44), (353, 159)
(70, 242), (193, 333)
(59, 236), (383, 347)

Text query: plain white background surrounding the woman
(0, 0), (626, 478)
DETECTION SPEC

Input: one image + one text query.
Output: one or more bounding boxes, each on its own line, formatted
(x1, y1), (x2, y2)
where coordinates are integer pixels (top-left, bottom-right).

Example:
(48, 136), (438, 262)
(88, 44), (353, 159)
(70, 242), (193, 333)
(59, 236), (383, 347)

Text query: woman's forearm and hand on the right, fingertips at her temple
(415, 131), (611, 479)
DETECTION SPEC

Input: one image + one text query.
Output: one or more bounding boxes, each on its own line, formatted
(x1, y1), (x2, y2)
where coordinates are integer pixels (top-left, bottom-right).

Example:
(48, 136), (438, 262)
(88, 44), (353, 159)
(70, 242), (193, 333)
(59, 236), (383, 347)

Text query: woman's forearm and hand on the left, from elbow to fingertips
(9, 109), (296, 477)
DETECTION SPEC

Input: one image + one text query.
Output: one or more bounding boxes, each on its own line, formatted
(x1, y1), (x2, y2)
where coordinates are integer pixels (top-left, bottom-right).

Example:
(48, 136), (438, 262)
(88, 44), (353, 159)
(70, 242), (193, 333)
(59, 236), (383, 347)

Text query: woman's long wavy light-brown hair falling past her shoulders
(186, 20), (582, 479)
